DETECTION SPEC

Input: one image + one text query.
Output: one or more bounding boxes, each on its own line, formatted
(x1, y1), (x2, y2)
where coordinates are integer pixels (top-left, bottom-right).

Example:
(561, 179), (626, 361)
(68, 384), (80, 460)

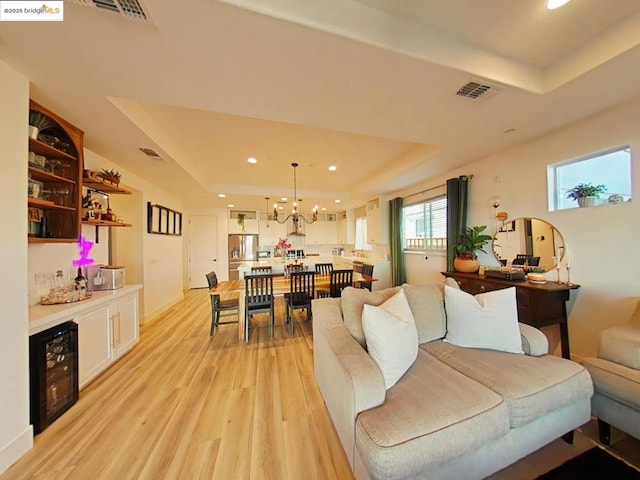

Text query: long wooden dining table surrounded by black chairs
(209, 272), (378, 341)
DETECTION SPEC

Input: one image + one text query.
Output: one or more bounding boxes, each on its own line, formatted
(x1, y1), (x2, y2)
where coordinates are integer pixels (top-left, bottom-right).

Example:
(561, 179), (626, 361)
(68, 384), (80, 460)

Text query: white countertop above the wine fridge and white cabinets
(29, 285), (142, 335)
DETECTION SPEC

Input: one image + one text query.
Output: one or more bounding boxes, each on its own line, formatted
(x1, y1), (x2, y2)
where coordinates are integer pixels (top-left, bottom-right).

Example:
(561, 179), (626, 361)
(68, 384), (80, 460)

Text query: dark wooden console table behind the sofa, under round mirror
(442, 272), (580, 358)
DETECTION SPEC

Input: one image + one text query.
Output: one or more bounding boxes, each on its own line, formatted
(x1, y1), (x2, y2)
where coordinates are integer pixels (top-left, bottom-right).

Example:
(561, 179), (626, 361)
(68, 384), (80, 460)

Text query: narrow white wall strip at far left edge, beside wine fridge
(0, 62), (33, 473)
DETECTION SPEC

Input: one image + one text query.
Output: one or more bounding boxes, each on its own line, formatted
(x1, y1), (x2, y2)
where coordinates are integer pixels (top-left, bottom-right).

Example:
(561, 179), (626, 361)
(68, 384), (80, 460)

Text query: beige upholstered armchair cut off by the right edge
(584, 304), (640, 445)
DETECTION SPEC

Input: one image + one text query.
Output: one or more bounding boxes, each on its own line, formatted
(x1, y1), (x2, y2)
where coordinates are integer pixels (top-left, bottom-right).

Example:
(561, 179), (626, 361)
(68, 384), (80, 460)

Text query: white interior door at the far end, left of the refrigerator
(189, 215), (220, 288)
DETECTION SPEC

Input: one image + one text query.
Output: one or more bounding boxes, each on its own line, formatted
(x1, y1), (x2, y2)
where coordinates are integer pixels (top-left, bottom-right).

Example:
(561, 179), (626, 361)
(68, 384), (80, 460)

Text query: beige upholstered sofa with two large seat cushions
(312, 285), (593, 480)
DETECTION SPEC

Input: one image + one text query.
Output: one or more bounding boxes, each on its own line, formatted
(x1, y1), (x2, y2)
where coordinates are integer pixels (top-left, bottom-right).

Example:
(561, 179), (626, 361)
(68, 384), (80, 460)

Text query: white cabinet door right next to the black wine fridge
(75, 304), (113, 389)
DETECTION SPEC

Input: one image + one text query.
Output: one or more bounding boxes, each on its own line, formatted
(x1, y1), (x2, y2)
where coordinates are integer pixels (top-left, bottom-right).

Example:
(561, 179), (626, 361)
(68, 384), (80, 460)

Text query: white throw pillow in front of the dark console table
(444, 285), (524, 353)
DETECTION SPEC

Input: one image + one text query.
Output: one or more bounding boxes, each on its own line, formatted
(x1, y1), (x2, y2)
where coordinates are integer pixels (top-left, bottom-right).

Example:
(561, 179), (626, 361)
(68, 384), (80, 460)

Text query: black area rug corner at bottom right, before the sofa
(536, 447), (640, 480)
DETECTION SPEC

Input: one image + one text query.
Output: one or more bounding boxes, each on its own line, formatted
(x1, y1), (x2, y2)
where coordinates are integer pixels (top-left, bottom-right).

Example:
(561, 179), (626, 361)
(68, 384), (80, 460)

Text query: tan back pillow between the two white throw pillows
(402, 283), (447, 343)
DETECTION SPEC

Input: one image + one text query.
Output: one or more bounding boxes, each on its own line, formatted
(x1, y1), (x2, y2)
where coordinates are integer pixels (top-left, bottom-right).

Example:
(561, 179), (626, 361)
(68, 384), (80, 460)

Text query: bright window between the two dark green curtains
(402, 196), (447, 251)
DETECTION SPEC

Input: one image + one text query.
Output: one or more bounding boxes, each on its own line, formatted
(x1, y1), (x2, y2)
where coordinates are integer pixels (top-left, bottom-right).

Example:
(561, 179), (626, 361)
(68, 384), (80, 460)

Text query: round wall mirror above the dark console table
(492, 217), (564, 272)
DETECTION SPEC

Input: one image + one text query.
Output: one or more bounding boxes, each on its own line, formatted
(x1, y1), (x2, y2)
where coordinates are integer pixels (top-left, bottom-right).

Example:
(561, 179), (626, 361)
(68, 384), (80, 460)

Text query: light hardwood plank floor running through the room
(5, 290), (640, 480)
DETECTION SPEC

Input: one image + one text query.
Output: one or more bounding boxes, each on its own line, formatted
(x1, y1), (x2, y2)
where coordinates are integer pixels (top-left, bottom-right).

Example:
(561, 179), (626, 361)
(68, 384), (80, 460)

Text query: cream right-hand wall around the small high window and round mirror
(399, 99), (640, 357)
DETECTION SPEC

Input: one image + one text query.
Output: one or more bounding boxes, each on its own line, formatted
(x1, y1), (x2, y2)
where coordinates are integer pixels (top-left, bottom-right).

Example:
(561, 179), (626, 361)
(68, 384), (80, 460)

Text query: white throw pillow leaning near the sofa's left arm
(362, 290), (418, 390)
